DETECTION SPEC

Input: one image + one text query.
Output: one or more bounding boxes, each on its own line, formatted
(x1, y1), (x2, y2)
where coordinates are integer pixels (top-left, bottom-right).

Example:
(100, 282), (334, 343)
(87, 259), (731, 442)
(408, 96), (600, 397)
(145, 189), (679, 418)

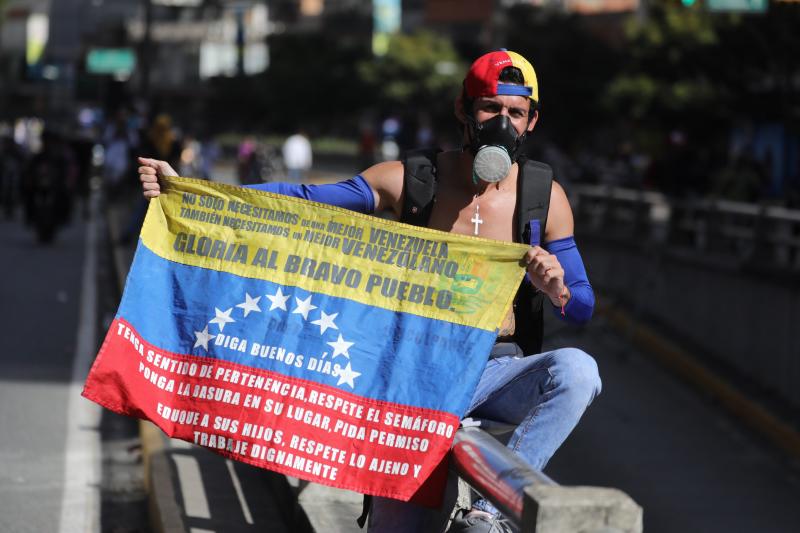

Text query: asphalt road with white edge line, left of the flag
(0, 194), (148, 533)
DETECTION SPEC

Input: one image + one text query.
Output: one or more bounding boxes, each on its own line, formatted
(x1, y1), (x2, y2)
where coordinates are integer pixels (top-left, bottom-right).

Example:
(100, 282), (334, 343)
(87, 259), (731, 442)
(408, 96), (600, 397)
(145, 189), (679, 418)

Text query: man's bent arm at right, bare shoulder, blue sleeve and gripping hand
(525, 182), (594, 324)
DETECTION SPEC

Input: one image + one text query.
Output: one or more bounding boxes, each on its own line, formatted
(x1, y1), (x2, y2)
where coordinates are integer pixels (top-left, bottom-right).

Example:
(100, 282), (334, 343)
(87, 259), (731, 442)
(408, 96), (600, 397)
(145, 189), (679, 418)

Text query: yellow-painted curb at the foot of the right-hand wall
(598, 304), (800, 460)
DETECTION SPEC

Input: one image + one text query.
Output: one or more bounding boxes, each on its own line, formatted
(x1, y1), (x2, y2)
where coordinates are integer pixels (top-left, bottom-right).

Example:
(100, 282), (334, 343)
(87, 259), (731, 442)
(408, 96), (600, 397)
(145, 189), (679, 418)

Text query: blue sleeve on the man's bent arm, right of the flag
(543, 237), (594, 324)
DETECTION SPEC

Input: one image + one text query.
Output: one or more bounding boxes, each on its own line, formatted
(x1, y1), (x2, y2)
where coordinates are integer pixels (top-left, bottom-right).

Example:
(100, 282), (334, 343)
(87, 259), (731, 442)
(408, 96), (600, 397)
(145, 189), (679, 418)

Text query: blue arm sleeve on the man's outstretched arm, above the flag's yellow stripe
(246, 176), (375, 215)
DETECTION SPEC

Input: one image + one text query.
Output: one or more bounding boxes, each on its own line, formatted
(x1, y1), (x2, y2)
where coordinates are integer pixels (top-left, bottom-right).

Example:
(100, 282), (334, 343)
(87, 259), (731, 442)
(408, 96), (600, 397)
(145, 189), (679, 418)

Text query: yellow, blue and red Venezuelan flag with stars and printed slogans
(83, 178), (527, 500)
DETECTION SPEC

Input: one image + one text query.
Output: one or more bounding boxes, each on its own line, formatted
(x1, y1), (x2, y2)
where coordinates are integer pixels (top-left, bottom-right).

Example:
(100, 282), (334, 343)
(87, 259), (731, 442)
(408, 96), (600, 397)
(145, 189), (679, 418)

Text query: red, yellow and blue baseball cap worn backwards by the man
(464, 50), (539, 103)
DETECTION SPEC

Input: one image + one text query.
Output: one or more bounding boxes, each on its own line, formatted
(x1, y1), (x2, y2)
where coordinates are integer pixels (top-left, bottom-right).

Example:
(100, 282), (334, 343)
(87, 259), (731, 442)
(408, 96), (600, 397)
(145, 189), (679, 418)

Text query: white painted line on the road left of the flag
(58, 197), (101, 533)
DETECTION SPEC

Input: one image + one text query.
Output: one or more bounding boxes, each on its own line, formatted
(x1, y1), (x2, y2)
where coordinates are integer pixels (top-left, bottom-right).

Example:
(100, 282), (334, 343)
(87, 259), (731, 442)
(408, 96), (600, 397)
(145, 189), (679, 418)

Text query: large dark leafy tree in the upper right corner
(604, 0), (800, 148)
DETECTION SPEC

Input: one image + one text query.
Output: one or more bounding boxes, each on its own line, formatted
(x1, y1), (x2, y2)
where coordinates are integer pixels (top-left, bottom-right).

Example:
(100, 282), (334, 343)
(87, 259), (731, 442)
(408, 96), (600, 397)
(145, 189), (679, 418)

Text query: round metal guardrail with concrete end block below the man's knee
(451, 427), (642, 533)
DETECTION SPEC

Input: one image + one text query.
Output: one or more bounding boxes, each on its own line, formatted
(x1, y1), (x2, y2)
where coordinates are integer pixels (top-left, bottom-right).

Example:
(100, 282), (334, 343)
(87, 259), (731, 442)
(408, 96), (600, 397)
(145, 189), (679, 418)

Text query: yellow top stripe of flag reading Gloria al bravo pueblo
(141, 178), (528, 331)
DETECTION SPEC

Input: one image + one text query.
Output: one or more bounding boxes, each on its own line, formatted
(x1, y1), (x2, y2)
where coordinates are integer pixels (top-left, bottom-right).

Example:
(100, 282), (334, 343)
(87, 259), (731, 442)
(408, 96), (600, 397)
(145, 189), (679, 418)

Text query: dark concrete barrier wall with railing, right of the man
(570, 181), (800, 409)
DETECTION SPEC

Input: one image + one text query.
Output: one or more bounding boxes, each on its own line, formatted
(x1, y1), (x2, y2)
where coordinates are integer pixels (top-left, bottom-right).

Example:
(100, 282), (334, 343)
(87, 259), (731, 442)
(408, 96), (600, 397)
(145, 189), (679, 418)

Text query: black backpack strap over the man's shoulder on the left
(400, 149), (440, 226)
